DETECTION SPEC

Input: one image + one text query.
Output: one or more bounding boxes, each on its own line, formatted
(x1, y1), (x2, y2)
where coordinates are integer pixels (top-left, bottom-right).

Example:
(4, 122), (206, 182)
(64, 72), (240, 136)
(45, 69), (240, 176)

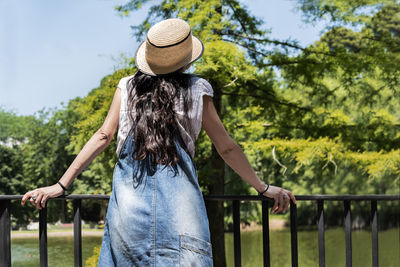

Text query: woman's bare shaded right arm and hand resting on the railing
(202, 95), (296, 215)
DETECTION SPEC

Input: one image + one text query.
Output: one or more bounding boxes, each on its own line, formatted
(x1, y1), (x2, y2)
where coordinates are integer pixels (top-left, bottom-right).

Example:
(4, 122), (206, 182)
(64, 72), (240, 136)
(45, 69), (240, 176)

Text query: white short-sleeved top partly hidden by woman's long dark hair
(116, 75), (214, 159)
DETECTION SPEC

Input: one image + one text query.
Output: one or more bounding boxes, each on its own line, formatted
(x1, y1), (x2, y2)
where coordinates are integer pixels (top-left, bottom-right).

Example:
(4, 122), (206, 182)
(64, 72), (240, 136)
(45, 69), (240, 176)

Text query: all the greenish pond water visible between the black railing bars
(11, 228), (400, 267)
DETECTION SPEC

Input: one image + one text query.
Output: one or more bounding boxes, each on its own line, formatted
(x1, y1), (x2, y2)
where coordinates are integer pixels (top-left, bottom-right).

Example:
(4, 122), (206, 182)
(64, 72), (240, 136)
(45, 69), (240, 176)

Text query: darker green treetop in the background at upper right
(282, 4), (400, 90)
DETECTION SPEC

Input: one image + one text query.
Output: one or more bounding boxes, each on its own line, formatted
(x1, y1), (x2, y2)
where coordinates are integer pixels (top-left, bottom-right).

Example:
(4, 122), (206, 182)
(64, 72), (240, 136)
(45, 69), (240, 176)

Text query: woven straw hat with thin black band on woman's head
(135, 18), (204, 76)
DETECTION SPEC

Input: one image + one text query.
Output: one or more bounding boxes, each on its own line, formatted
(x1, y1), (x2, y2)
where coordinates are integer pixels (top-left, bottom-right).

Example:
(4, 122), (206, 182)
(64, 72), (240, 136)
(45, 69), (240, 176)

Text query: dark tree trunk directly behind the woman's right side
(206, 87), (226, 267)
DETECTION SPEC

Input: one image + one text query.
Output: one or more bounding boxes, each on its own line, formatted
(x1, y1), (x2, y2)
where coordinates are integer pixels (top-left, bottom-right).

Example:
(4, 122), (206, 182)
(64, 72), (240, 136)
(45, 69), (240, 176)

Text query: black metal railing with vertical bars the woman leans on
(0, 195), (400, 267)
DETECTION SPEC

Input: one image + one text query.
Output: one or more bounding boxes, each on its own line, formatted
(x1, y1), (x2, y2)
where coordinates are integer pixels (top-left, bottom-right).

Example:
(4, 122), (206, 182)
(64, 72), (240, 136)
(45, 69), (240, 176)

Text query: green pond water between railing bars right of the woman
(225, 228), (400, 267)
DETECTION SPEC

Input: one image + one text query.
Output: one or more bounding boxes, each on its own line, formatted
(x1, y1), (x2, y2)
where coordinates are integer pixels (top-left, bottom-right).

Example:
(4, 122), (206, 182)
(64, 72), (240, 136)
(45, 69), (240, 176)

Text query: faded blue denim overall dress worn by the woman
(98, 76), (213, 267)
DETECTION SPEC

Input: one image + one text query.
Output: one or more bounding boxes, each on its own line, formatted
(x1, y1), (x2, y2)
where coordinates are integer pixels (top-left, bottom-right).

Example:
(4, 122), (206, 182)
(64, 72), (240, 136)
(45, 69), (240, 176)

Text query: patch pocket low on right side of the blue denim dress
(179, 233), (213, 267)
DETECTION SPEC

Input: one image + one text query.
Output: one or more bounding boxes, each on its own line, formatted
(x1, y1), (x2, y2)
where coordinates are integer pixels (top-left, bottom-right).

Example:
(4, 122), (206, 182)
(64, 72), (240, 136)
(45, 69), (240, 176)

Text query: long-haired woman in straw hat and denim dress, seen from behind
(22, 19), (296, 266)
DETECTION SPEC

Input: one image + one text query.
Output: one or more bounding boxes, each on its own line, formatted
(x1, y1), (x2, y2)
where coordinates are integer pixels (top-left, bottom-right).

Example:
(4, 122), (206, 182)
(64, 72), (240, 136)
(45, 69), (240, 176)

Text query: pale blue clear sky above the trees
(0, 0), (323, 115)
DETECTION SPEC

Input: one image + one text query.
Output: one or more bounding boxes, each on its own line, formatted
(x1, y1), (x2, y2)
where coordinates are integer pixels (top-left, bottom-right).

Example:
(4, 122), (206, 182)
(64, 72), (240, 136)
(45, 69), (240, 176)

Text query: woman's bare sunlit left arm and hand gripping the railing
(21, 87), (121, 209)
